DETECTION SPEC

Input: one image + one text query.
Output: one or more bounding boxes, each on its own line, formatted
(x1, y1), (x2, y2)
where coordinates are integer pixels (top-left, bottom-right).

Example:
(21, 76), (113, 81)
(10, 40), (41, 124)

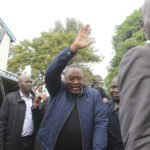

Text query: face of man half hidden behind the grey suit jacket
(110, 77), (119, 103)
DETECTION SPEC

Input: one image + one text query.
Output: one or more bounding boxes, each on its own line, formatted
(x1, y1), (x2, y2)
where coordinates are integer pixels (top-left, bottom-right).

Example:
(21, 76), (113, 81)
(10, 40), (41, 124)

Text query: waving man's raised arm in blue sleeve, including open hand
(45, 25), (93, 96)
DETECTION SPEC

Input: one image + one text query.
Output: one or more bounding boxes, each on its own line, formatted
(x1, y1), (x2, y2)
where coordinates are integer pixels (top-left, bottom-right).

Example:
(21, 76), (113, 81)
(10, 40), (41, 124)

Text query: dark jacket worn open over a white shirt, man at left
(0, 90), (35, 150)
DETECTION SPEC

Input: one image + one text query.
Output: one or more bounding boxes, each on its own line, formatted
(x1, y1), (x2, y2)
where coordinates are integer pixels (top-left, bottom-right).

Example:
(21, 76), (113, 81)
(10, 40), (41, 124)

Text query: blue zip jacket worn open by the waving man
(37, 47), (108, 150)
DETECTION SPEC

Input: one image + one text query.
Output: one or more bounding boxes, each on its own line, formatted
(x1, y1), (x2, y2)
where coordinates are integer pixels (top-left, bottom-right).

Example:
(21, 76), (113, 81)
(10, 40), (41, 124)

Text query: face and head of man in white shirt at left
(18, 76), (33, 93)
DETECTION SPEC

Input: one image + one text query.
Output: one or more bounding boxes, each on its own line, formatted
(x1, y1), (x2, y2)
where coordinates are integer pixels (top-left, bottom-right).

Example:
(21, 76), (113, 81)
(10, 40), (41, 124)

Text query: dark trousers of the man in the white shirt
(20, 136), (34, 150)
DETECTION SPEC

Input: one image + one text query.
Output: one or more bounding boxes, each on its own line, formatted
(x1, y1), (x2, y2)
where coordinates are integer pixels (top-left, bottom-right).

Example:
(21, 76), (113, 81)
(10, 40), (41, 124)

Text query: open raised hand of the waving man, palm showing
(70, 25), (93, 52)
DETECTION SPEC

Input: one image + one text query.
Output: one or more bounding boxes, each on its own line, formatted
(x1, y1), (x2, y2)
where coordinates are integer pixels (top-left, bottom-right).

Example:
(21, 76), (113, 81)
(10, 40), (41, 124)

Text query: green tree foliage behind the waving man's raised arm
(7, 18), (101, 84)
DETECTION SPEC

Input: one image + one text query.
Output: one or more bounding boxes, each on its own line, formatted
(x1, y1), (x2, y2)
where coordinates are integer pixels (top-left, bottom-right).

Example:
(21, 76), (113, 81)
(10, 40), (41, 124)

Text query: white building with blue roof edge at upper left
(0, 18), (16, 70)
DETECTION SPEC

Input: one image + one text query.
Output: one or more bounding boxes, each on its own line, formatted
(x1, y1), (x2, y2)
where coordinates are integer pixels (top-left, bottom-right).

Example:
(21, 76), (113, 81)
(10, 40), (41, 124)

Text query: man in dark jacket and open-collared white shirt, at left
(0, 76), (38, 150)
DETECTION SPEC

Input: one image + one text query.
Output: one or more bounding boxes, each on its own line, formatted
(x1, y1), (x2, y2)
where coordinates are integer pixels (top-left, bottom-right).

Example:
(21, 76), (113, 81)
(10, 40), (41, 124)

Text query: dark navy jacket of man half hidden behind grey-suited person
(106, 100), (124, 150)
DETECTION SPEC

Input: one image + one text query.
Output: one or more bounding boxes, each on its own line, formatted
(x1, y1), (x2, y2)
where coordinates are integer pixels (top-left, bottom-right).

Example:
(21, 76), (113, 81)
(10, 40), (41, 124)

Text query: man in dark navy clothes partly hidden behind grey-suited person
(106, 76), (124, 150)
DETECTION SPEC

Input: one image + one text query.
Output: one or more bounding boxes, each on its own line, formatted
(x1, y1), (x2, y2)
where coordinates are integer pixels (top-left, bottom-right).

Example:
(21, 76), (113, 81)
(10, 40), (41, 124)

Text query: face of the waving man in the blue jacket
(65, 67), (84, 94)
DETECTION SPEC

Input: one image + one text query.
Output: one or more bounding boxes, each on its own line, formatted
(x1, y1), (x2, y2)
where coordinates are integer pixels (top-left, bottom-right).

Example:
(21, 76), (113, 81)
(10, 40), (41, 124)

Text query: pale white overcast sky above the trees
(0, 0), (144, 78)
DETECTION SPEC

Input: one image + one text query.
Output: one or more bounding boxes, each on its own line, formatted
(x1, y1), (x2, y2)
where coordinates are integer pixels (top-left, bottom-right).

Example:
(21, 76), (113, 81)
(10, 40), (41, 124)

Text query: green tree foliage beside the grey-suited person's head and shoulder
(105, 9), (145, 91)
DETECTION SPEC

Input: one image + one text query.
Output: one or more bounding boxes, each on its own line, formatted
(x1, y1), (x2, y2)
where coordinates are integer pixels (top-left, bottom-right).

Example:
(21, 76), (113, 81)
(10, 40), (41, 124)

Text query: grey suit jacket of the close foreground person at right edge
(118, 45), (150, 150)
